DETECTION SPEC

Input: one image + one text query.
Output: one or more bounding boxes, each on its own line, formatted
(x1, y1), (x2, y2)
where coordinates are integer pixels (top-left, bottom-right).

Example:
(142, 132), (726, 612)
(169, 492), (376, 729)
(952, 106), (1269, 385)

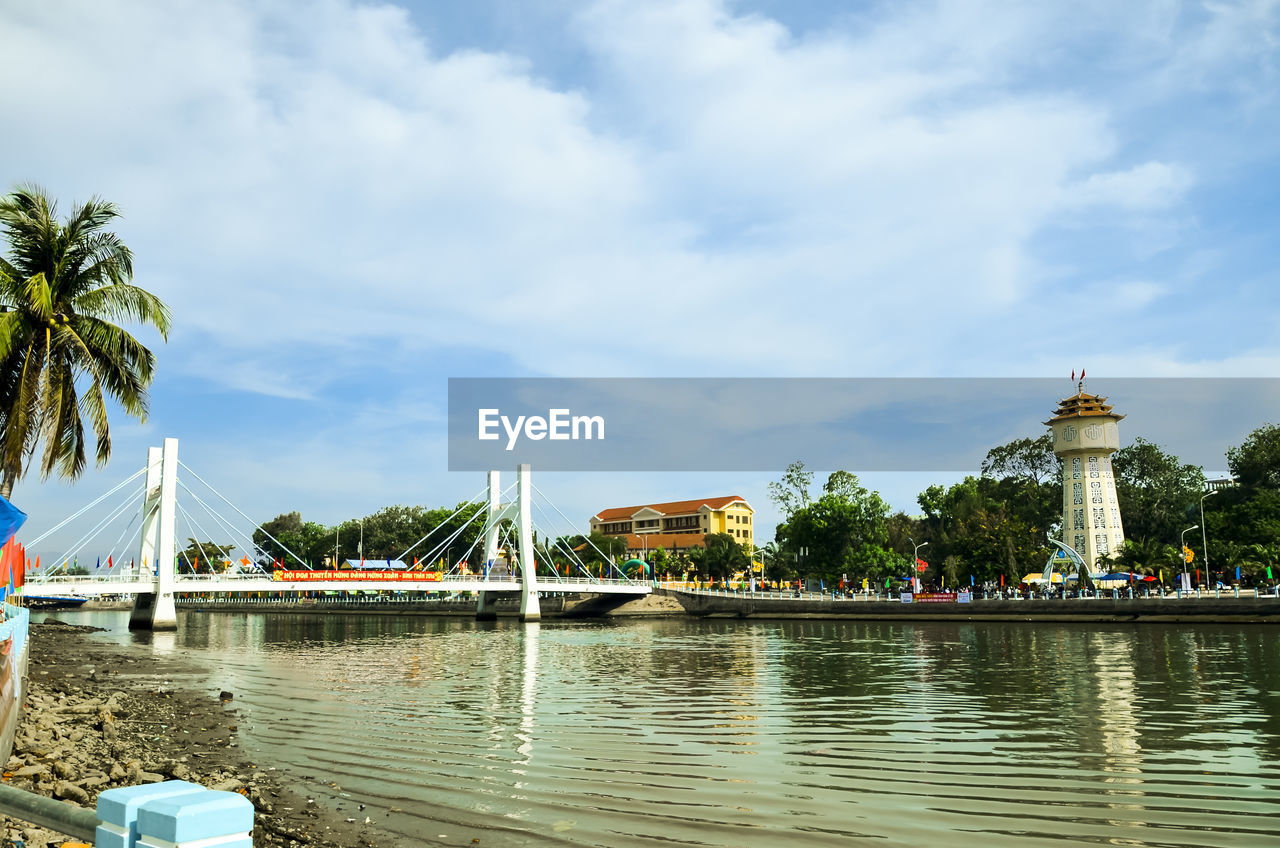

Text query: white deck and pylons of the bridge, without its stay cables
(24, 438), (650, 630)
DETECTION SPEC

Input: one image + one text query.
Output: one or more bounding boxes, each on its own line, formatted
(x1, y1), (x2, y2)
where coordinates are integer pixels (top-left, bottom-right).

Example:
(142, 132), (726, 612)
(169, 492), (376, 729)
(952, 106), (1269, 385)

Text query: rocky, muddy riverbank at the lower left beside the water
(0, 621), (455, 848)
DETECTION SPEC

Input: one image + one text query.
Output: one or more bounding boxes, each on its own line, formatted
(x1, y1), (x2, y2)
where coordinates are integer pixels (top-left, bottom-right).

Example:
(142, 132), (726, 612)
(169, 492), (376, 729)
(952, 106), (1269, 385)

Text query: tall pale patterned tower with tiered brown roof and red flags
(1044, 380), (1124, 574)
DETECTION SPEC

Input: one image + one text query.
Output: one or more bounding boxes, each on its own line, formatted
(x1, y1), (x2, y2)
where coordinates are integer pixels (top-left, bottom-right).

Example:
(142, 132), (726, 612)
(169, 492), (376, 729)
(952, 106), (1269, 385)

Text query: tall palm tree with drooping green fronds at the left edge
(0, 186), (169, 498)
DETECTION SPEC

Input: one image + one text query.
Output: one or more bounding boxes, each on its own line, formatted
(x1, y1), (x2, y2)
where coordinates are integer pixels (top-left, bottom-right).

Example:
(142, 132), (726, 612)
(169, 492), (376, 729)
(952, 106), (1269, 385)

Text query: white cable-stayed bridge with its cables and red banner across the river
(15, 438), (650, 630)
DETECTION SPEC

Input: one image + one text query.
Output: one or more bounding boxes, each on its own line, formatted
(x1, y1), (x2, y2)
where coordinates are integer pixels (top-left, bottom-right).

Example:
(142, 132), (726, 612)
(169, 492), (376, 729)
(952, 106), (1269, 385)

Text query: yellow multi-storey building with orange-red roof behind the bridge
(591, 494), (755, 553)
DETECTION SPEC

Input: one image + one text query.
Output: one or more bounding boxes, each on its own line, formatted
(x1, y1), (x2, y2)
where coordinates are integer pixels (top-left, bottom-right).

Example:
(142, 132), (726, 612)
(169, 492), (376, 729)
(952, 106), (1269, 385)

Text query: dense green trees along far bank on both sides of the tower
(768, 424), (1280, 585)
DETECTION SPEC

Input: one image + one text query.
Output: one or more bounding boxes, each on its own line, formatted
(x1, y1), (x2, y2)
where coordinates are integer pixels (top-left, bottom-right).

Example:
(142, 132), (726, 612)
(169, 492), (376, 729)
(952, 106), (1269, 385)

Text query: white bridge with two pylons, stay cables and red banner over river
(23, 438), (652, 630)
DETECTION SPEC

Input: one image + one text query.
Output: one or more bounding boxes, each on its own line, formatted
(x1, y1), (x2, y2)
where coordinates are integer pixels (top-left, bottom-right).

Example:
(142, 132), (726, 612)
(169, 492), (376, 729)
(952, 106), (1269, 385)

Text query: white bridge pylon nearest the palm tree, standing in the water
(129, 438), (178, 630)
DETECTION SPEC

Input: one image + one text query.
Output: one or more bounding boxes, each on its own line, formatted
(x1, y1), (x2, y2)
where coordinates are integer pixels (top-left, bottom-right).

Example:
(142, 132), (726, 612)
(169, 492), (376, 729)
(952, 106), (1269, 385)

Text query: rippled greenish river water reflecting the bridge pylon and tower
(45, 614), (1280, 848)
